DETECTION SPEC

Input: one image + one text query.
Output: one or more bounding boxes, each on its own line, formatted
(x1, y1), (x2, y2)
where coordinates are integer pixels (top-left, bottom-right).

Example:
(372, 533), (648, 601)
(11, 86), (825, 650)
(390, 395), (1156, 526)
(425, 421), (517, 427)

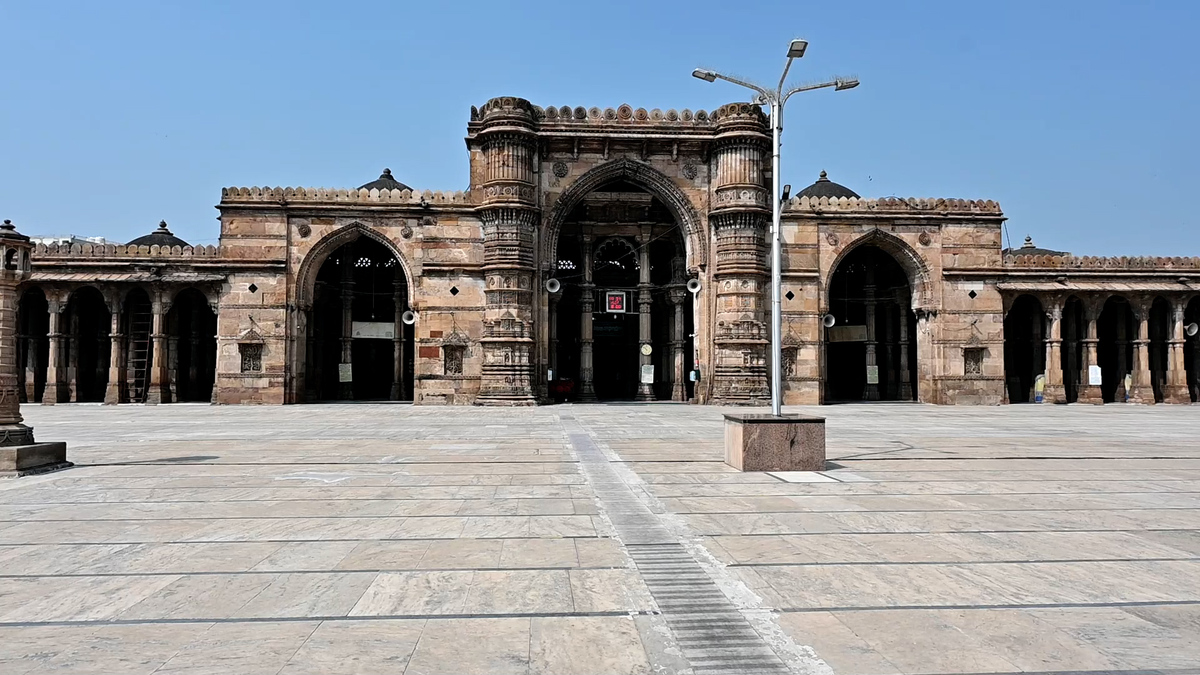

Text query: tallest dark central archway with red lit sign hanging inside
(550, 181), (694, 401)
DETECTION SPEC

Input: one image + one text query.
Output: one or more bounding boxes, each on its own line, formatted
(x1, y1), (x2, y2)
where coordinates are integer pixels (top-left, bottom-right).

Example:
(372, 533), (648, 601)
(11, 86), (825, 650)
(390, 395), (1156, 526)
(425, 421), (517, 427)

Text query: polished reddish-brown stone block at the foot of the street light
(725, 413), (826, 471)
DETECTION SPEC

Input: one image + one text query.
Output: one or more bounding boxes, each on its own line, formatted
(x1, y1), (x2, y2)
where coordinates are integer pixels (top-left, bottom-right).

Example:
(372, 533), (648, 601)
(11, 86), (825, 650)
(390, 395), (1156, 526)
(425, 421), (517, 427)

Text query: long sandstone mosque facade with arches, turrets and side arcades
(16, 97), (1200, 406)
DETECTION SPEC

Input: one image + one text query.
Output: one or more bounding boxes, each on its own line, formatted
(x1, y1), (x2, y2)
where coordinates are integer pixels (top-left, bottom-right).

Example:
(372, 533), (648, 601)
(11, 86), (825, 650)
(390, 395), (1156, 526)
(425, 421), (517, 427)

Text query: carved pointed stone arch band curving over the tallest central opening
(541, 157), (708, 269)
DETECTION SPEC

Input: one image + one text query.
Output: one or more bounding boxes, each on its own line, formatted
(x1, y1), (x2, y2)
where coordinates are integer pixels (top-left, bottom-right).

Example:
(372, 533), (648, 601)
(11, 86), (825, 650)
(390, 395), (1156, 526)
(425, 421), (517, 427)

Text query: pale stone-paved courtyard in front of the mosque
(0, 404), (1200, 675)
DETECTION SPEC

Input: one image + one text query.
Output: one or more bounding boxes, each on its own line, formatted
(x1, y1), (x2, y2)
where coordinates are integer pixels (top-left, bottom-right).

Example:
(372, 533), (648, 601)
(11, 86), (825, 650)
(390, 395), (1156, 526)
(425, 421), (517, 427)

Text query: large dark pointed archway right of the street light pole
(824, 245), (917, 402)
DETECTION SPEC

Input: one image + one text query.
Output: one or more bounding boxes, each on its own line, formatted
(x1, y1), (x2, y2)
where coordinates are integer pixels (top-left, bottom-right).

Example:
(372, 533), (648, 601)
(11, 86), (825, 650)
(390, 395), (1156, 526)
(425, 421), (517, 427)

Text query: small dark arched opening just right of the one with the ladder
(167, 288), (217, 401)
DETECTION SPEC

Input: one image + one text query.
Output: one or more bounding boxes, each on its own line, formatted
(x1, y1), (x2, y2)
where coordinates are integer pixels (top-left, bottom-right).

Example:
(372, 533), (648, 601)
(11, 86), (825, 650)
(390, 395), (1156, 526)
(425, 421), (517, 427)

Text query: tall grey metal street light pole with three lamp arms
(691, 40), (858, 417)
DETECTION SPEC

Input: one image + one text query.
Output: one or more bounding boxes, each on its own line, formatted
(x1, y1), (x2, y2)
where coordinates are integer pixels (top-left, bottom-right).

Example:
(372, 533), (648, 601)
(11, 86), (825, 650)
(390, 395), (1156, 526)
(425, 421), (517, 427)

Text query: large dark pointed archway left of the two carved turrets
(305, 237), (413, 401)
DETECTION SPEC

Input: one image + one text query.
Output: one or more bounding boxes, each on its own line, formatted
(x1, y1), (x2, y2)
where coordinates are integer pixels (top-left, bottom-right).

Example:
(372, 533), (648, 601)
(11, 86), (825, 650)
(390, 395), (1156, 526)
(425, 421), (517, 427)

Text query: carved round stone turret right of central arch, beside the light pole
(709, 103), (770, 405)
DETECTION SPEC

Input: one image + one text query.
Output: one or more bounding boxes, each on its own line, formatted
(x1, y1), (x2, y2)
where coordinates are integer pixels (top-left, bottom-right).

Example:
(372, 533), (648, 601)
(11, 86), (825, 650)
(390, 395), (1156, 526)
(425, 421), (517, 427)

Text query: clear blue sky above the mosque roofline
(0, 0), (1200, 255)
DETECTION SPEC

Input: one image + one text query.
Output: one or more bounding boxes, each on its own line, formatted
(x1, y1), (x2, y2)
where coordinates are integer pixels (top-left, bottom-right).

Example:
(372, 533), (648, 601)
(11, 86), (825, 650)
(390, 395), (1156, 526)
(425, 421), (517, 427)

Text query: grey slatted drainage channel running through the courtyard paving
(560, 416), (791, 675)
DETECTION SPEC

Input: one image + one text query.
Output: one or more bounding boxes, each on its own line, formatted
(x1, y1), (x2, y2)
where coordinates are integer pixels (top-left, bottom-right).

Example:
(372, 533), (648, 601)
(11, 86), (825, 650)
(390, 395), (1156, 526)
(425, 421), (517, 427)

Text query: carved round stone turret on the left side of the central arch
(468, 97), (539, 406)
